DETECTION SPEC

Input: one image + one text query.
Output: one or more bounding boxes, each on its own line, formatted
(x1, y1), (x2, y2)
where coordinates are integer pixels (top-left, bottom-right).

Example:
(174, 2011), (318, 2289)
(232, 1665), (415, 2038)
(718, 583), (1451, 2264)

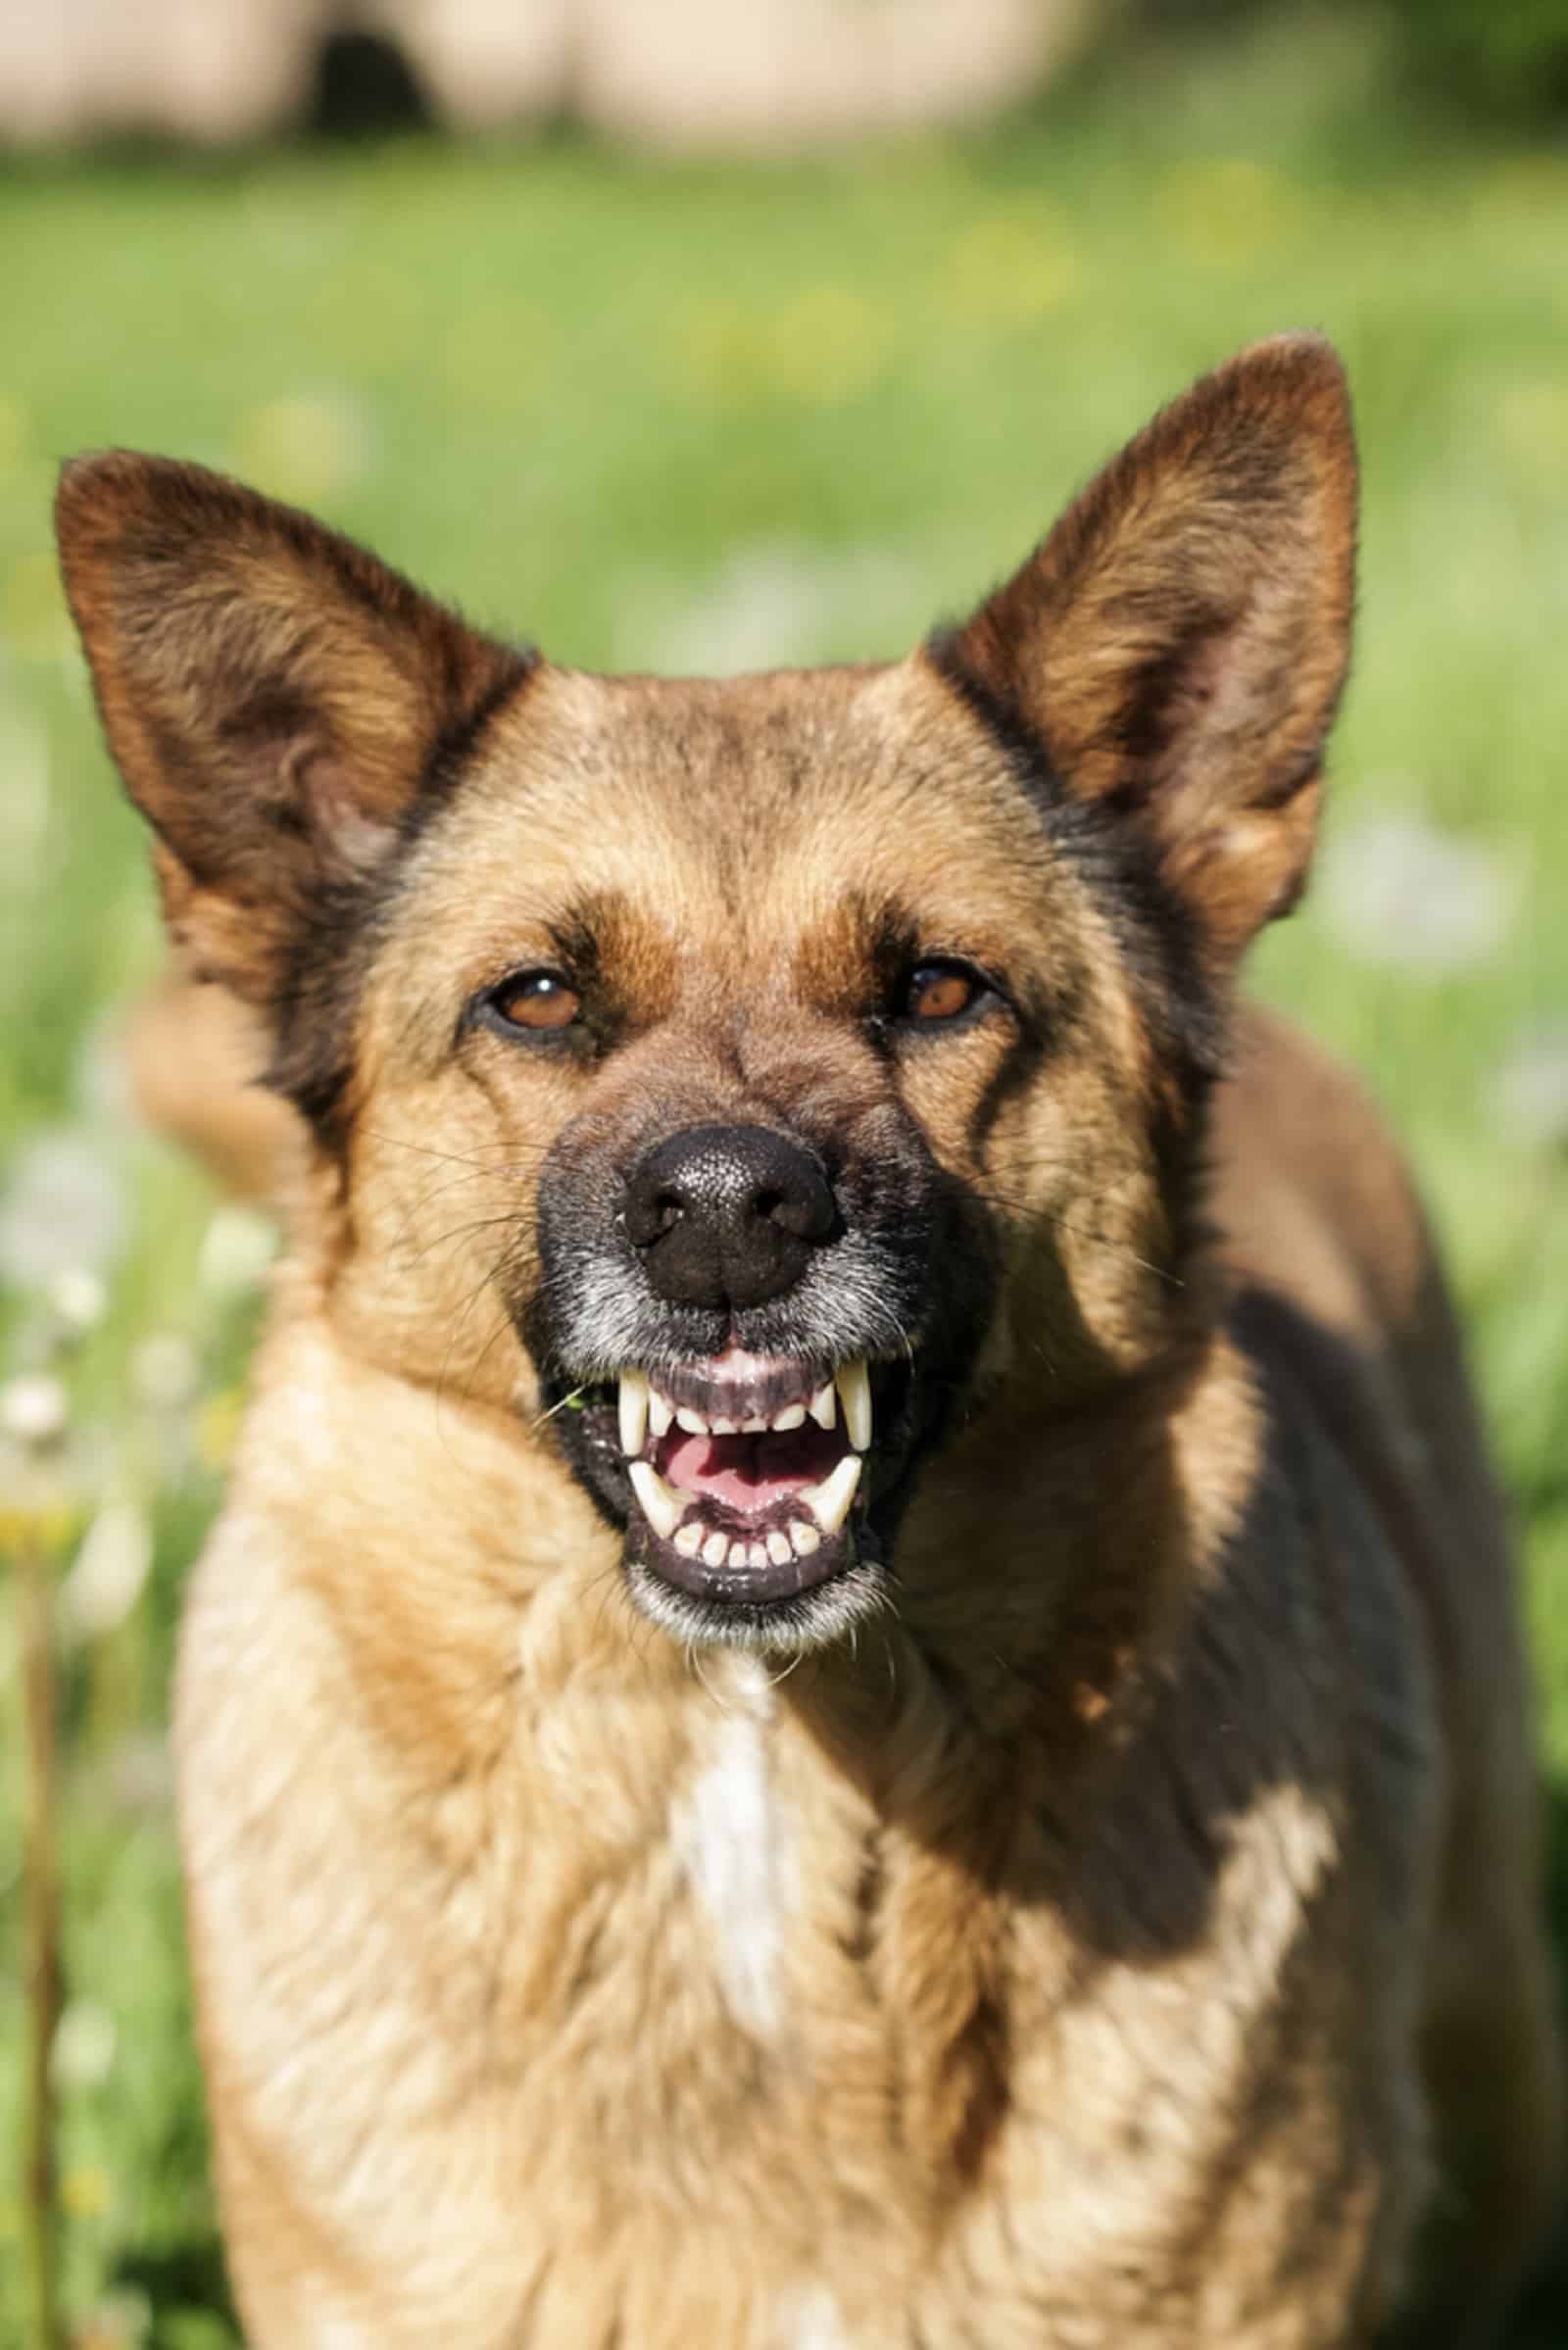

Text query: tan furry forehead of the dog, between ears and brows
(411, 656), (1049, 954)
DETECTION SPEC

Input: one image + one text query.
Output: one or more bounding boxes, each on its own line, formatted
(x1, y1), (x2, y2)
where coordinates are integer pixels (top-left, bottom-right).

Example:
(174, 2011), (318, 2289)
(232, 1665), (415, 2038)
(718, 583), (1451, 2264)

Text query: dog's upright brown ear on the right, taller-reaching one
(950, 336), (1356, 973)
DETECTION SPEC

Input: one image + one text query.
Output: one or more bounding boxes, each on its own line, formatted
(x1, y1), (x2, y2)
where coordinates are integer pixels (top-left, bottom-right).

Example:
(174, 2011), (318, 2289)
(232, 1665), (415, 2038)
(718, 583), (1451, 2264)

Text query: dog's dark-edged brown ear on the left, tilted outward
(57, 451), (526, 1005)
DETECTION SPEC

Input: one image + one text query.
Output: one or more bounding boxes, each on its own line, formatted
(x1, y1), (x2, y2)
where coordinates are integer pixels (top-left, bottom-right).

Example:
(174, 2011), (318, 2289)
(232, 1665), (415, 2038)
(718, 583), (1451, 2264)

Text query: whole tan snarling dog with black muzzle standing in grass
(59, 338), (1558, 2350)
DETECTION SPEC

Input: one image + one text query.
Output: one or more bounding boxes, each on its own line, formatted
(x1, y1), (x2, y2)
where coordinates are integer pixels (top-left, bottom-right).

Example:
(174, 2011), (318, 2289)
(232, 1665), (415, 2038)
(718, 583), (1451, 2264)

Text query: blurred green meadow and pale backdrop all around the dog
(0, 0), (1568, 2350)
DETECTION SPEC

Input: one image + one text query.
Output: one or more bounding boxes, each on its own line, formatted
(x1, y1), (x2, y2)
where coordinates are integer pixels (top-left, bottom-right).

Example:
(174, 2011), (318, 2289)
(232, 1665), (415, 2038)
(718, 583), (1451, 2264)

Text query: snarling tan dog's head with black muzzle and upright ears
(59, 338), (1354, 1645)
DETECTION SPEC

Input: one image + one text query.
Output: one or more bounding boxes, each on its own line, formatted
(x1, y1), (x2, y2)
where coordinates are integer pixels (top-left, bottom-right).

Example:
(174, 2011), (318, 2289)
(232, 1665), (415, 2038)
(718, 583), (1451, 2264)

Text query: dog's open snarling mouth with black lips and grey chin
(555, 1346), (921, 1654)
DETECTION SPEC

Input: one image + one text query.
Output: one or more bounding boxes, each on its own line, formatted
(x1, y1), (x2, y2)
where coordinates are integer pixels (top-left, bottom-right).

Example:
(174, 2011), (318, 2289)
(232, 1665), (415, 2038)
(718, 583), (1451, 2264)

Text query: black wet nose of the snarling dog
(625, 1126), (837, 1306)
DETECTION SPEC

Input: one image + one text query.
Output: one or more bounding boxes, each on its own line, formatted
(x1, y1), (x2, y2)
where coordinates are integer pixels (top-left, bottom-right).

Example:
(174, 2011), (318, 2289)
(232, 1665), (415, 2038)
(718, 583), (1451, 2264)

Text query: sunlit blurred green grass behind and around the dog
(0, 22), (1568, 2350)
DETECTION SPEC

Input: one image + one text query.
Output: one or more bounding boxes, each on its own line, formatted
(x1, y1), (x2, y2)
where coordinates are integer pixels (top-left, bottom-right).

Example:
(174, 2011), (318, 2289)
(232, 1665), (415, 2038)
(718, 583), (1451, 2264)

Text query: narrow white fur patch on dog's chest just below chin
(672, 1701), (788, 2039)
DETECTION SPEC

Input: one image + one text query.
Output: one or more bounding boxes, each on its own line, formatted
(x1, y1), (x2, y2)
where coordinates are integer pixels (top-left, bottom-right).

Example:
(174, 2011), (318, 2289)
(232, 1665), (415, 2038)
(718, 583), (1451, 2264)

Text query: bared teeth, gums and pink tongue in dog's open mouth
(618, 1346), (872, 1602)
